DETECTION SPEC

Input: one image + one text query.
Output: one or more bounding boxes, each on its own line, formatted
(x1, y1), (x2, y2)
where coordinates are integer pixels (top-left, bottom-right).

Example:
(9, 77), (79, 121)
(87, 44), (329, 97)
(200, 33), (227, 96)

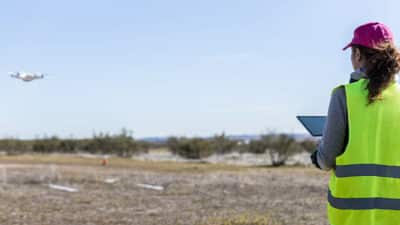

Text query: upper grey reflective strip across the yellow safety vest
(335, 164), (400, 178)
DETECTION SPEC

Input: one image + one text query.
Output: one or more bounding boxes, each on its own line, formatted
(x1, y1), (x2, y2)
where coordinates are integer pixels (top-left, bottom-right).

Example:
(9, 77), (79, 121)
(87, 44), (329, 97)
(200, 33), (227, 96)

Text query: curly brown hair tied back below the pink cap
(352, 42), (400, 104)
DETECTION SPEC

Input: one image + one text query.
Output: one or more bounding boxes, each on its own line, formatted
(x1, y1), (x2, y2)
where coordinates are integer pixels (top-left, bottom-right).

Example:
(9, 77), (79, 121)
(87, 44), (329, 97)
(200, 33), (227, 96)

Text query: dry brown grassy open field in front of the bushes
(0, 155), (328, 225)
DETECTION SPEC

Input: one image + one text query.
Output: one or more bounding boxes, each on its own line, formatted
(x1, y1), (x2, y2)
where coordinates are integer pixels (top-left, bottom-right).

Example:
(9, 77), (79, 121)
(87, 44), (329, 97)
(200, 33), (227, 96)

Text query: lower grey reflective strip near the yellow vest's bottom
(328, 191), (400, 210)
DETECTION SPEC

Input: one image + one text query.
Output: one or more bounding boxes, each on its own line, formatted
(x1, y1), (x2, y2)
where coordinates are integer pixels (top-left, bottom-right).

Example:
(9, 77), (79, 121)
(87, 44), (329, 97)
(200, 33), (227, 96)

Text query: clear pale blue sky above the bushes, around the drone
(0, 0), (400, 138)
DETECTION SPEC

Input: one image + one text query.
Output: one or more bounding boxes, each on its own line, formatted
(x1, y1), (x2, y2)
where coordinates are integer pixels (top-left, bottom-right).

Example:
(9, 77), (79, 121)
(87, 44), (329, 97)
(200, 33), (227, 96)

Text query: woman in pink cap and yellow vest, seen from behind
(312, 23), (400, 225)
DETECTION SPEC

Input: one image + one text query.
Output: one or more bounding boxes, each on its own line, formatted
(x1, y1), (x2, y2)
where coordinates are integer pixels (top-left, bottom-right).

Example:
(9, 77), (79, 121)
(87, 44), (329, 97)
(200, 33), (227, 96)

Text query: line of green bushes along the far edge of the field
(0, 130), (317, 166)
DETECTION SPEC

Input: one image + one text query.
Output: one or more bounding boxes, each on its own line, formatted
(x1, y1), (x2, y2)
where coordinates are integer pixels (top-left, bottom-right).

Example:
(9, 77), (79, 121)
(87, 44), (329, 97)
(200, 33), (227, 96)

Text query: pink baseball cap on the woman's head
(343, 22), (394, 50)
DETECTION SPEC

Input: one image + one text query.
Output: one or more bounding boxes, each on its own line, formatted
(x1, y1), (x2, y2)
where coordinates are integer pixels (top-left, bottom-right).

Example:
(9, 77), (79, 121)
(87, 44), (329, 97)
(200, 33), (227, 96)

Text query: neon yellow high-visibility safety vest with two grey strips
(328, 79), (400, 225)
